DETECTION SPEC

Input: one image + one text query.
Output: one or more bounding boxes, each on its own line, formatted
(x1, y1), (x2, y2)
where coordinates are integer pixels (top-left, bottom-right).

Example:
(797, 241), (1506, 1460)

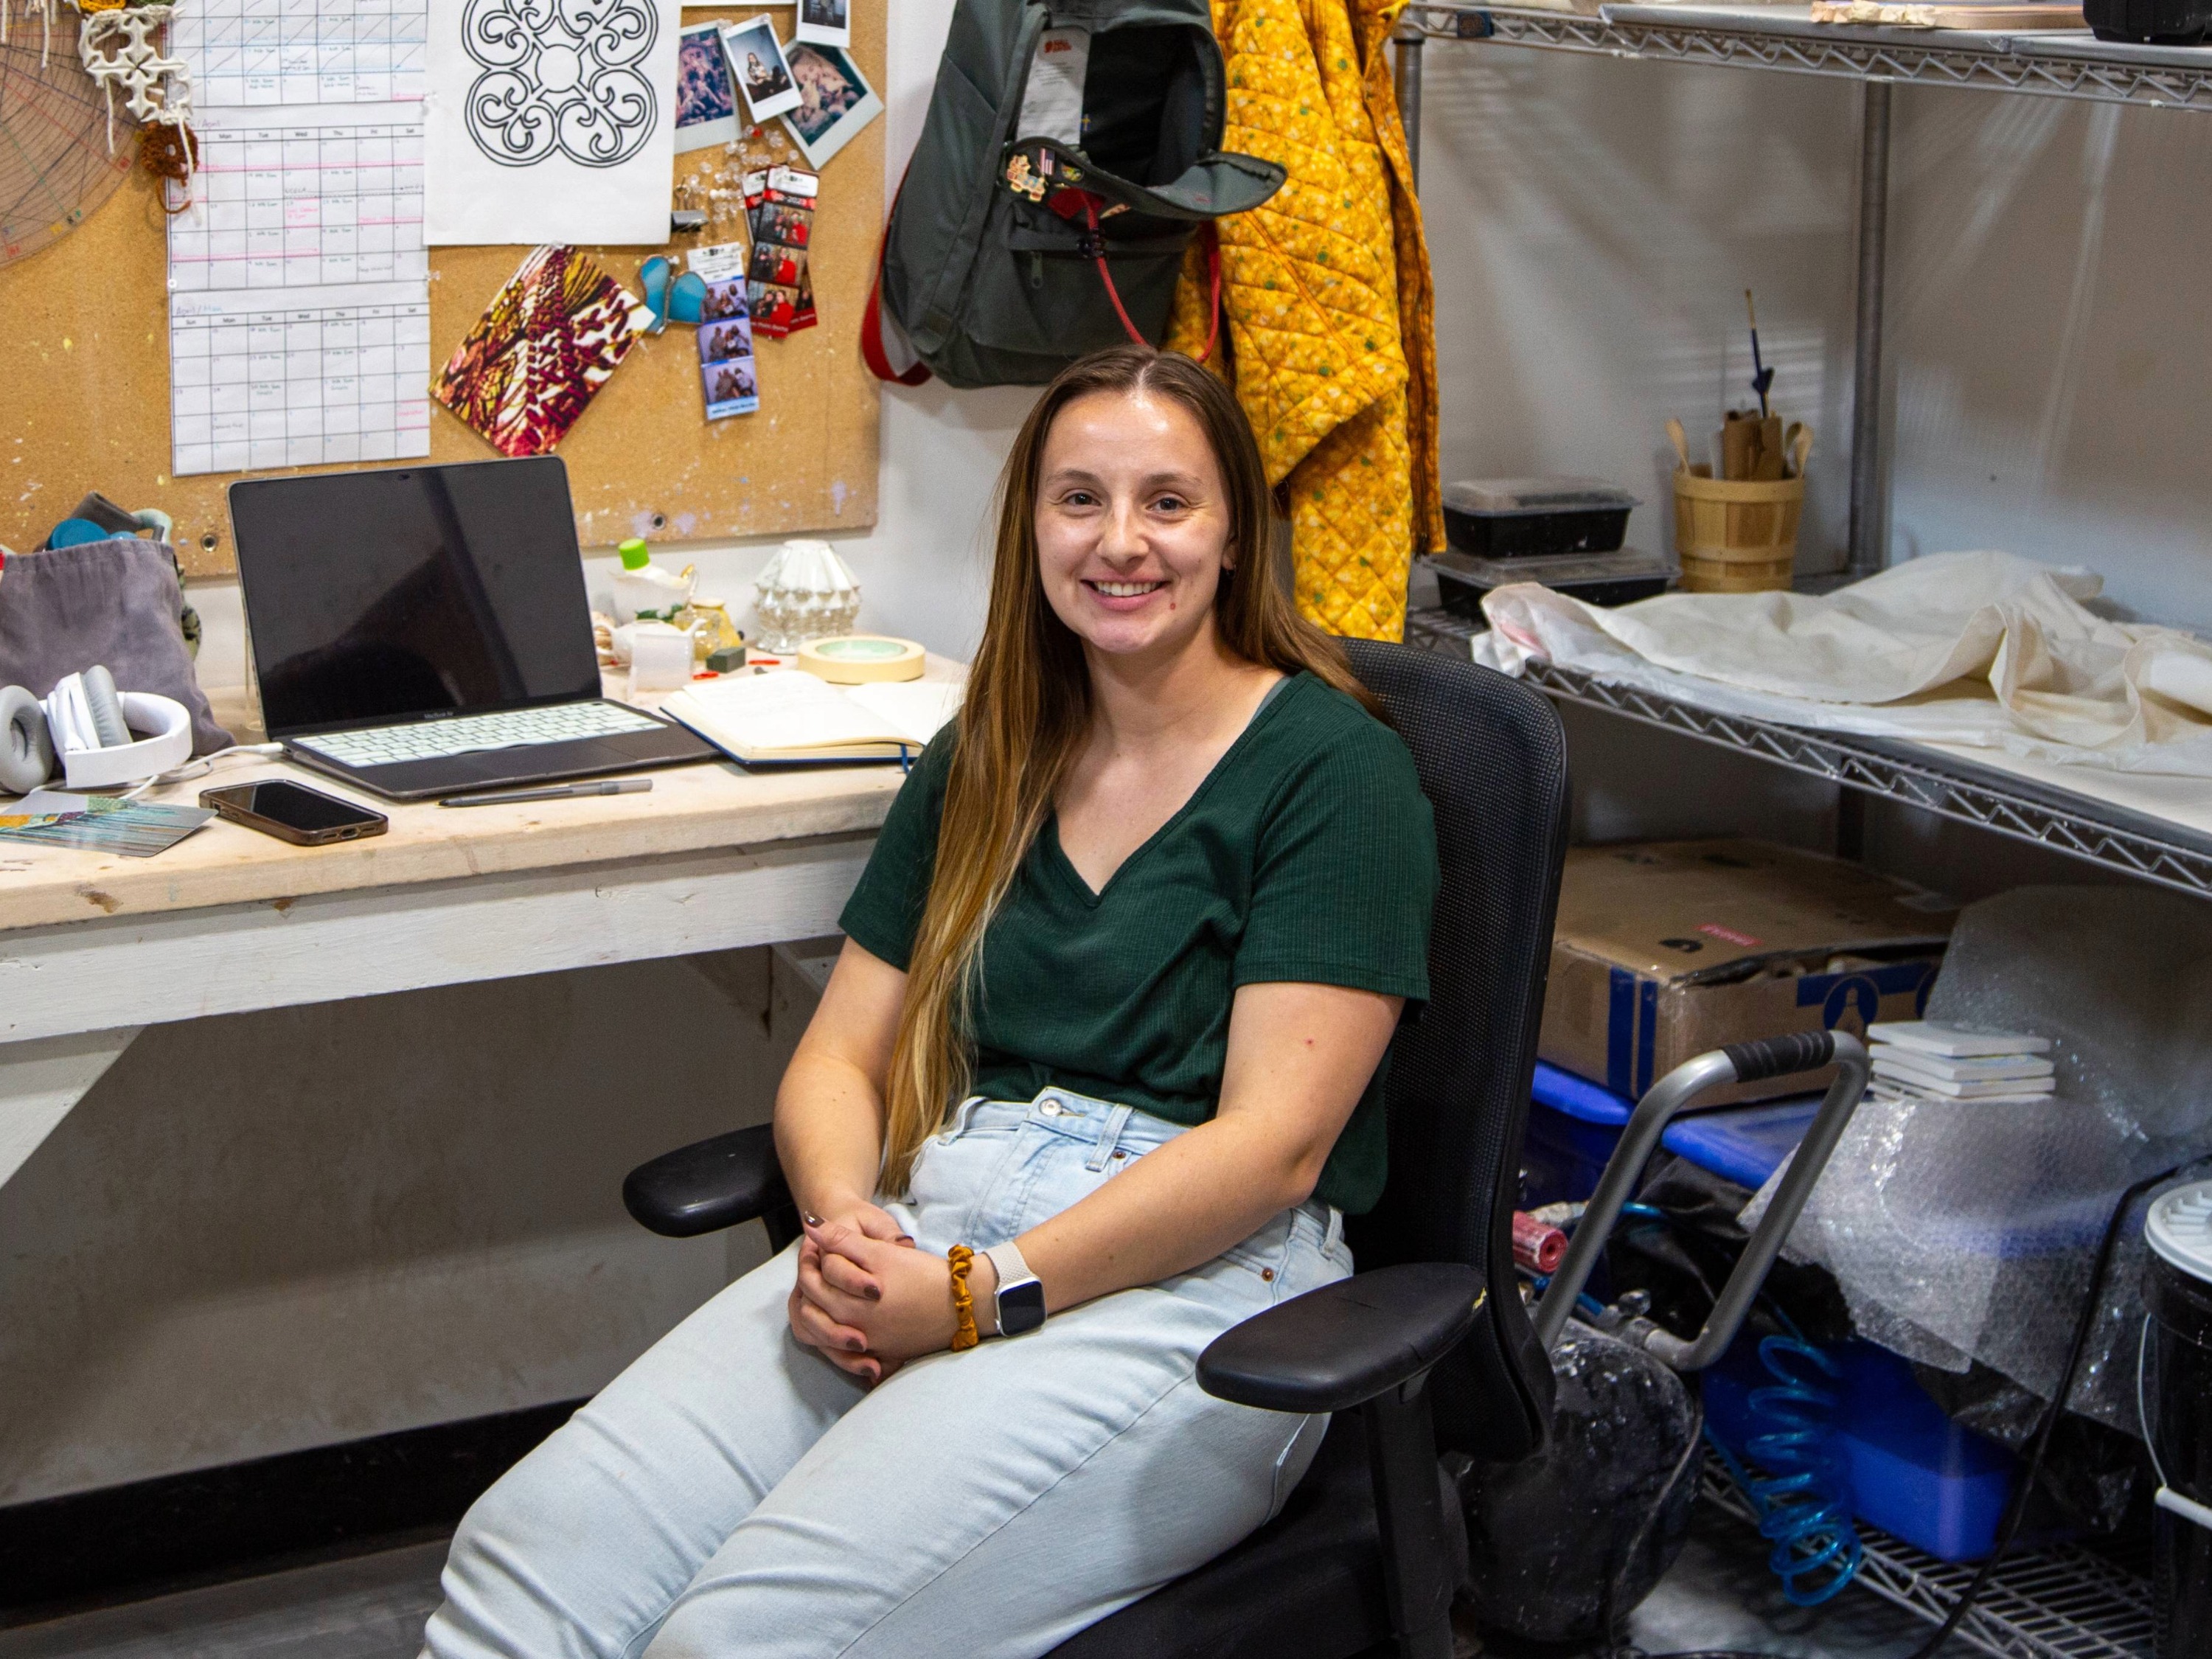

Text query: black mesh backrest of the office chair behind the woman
(1345, 639), (1568, 1462)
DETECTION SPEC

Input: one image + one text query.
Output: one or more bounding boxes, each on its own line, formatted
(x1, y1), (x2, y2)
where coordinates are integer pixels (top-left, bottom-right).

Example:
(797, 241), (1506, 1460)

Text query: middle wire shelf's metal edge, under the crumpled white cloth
(1407, 611), (2212, 898)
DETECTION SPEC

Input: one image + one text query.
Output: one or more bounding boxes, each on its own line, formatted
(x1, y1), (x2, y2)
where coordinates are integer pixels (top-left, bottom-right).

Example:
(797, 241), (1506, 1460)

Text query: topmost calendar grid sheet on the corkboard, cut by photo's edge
(173, 0), (429, 108)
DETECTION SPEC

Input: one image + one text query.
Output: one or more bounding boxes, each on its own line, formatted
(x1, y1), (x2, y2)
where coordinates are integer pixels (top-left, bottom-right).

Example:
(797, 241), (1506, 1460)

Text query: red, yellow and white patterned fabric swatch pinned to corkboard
(431, 248), (648, 456)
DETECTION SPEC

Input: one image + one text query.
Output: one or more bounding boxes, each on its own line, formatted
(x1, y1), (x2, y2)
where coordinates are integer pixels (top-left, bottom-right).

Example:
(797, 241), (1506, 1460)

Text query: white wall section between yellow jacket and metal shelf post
(1420, 42), (1854, 568)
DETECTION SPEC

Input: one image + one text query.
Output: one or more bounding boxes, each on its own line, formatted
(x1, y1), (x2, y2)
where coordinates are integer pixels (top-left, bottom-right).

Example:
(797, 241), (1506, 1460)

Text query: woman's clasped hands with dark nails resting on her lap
(790, 1203), (995, 1382)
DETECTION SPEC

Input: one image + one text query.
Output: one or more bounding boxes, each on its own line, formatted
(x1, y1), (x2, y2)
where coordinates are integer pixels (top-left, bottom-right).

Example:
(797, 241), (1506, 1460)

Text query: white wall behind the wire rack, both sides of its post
(1422, 42), (2212, 626)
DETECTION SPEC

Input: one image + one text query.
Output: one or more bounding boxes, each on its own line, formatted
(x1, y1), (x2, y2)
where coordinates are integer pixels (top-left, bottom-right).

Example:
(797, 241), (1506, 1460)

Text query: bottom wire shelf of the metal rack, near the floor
(1699, 1460), (2154, 1659)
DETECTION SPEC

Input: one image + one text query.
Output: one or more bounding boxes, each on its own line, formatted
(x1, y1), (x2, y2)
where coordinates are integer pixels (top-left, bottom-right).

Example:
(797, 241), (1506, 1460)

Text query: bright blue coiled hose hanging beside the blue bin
(1705, 1336), (1865, 1608)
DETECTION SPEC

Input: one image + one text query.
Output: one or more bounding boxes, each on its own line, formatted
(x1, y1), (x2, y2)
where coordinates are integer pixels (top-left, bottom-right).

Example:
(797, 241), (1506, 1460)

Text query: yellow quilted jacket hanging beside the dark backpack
(1168, 0), (1444, 639)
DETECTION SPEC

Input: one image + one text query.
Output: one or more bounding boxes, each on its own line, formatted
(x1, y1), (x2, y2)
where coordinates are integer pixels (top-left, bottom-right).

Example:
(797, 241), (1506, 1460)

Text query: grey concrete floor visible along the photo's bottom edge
(0, 1511), (1929, 1659)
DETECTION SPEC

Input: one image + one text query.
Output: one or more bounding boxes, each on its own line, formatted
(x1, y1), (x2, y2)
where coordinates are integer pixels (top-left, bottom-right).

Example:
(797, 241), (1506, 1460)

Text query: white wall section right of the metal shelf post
(1889, 88), (2212, 628)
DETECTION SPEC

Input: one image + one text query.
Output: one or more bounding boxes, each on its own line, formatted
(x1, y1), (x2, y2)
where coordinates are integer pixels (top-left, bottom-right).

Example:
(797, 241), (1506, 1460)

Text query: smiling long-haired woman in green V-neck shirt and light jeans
(427, 347), (1438, 1659)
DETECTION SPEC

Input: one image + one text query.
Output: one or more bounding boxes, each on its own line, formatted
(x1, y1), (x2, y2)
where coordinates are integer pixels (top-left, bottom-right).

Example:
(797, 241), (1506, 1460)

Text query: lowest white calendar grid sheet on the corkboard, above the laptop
(168, 294), (429, 476)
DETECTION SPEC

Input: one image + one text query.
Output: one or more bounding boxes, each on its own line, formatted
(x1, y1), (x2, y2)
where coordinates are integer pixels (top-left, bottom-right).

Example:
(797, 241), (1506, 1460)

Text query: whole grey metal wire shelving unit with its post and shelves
(1396, 0), (2212, 1659)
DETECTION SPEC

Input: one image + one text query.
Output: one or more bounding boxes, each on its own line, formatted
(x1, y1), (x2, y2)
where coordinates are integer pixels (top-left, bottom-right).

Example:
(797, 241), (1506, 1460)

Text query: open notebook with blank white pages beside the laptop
(661, 668), (967, 765)
